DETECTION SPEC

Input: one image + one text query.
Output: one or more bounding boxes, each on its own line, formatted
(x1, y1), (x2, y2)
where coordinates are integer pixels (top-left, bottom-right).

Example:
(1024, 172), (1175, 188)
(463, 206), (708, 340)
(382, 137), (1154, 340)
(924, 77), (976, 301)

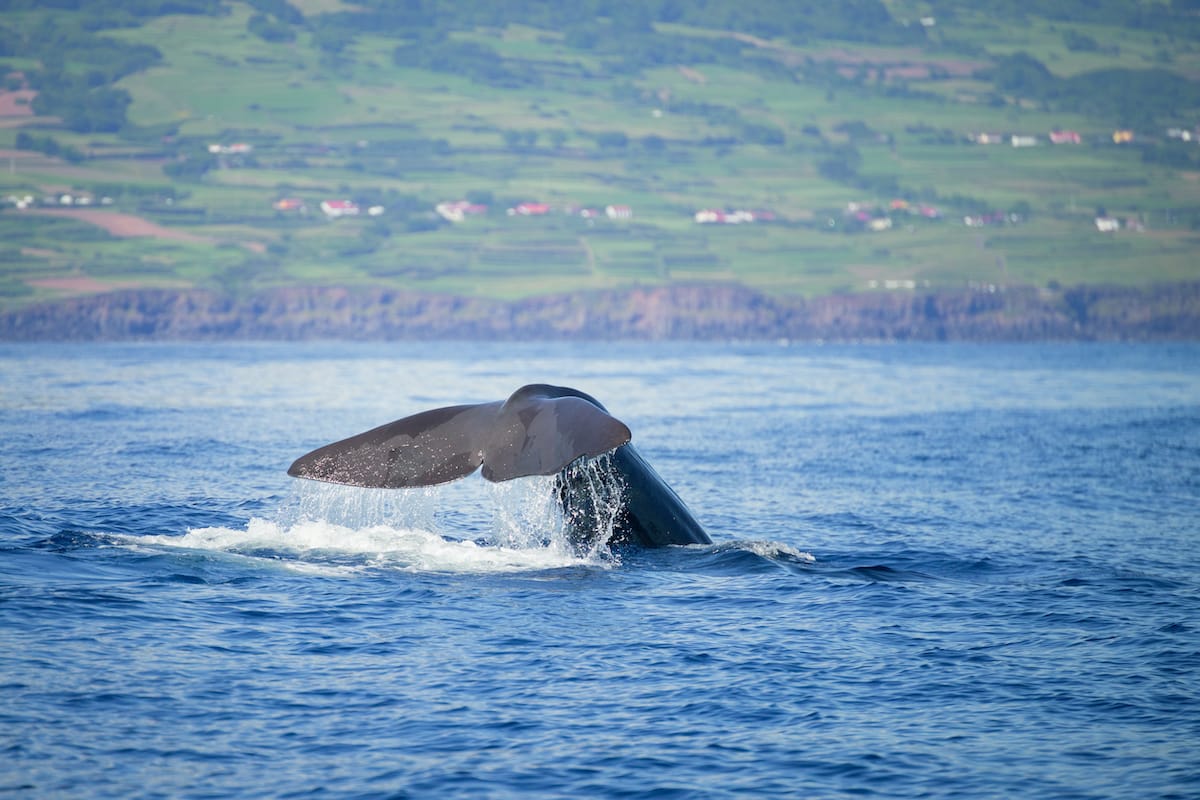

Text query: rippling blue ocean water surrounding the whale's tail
(0, 343), (1200, 798)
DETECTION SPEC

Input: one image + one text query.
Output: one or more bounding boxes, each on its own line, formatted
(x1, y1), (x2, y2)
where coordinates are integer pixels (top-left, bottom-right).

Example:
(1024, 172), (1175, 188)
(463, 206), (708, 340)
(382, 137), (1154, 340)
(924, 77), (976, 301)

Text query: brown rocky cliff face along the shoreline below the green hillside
(0, 282), (1200, 342)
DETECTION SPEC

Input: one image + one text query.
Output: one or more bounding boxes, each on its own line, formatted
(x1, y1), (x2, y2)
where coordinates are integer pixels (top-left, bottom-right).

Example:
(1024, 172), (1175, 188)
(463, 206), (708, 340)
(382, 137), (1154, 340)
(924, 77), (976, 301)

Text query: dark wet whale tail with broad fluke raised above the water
(288, 384), (712, 547)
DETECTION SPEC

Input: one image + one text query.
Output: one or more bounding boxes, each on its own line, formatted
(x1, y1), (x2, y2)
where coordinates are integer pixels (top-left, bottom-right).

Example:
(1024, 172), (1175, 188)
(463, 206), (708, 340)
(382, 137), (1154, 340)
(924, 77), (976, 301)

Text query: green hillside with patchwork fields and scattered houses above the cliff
(0, 0), (1200, 307)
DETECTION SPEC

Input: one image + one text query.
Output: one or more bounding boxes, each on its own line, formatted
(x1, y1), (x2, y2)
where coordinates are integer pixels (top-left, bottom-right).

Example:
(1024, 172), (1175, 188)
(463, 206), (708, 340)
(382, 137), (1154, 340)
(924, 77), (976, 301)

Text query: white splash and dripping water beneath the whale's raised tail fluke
(130, 456), (624, 575)
